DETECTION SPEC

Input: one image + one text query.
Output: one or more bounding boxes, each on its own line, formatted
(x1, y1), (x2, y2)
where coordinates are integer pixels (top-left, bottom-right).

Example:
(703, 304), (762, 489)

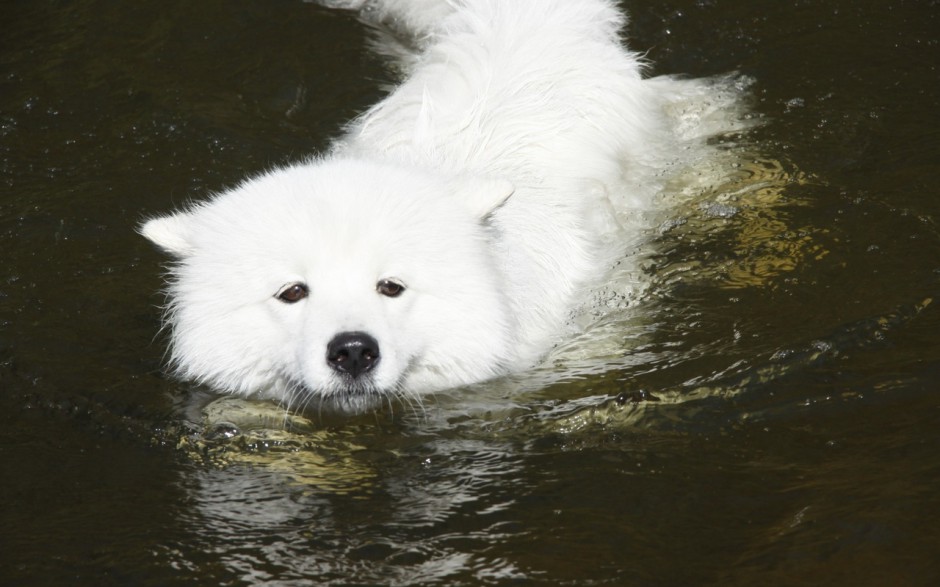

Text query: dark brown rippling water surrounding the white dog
(0, 0), (940, 585)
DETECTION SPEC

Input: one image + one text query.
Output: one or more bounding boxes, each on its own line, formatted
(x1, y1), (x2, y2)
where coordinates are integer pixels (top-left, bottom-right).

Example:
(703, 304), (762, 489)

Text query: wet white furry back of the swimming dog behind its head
(340, 0), (665, 360)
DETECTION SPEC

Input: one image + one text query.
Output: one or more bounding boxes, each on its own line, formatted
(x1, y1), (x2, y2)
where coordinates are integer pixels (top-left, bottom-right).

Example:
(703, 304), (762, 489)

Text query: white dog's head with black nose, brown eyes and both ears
(142, 160), (513, 411)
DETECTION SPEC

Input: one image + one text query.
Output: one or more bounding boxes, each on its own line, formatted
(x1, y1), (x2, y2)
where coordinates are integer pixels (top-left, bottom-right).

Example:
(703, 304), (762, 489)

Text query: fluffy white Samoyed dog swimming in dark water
(141, 0), (740, 412)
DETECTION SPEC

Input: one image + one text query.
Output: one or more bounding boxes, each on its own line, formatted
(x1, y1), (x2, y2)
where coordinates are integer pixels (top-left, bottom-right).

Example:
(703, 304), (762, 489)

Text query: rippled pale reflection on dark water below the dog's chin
(177, 422), (525, 585)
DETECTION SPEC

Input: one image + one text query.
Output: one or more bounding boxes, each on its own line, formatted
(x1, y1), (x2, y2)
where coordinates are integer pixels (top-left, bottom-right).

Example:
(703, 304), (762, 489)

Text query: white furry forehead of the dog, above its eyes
(196, 163), (480, 293)
